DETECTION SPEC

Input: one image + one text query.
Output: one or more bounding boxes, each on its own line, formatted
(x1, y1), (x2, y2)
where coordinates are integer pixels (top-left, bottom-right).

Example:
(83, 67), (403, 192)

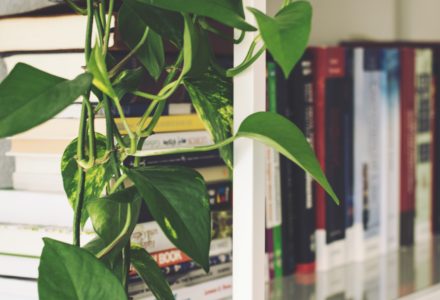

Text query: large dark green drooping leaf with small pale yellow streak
(126, 166), (211, 271)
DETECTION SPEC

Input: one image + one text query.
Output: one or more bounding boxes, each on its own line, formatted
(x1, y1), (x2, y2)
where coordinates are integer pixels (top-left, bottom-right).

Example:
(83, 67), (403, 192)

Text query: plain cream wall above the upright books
(268, 0), (440, 45)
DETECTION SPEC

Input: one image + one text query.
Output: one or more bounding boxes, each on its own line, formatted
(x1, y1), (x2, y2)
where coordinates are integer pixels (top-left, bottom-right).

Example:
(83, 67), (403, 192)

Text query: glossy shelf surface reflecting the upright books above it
(266, 237), (440, 300)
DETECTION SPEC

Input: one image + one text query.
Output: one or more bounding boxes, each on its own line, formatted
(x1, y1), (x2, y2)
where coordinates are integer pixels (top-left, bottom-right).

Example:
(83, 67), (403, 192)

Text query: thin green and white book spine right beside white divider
(266, 64), (283, 278)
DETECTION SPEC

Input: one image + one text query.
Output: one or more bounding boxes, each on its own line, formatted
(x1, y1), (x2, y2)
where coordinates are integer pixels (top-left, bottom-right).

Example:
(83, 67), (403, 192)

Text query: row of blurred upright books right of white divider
(266, 42), (440, 277)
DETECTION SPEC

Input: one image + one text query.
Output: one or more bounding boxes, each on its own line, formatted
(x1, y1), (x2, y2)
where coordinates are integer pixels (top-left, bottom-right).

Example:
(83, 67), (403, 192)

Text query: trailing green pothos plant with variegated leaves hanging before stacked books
(0, 0), (338, 300)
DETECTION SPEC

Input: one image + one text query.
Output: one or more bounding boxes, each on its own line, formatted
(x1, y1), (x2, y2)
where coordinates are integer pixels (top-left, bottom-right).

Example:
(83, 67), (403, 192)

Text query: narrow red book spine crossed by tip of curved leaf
(312, 48), (327, 229)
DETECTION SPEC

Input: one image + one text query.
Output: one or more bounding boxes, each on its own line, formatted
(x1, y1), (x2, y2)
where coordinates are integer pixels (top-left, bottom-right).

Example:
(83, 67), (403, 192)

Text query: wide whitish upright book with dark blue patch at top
(352, 48), (387, 260)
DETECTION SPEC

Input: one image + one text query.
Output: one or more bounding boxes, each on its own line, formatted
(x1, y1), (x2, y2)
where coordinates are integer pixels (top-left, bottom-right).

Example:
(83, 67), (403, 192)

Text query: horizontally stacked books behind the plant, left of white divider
(0, 0), (232, 299)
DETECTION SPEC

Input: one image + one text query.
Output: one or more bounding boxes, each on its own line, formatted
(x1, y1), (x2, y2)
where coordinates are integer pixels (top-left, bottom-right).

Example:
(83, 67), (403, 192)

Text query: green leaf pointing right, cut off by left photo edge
(0, 63), (92, 138)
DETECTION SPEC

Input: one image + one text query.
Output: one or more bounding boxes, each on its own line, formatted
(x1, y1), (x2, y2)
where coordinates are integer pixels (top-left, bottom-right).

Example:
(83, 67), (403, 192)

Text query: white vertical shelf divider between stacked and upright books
(233, 0), (266, 300)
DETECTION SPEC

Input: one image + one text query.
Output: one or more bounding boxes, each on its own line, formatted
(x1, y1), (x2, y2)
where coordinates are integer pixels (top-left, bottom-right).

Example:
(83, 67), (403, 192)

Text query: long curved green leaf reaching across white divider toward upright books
(236, 112), (339, 204)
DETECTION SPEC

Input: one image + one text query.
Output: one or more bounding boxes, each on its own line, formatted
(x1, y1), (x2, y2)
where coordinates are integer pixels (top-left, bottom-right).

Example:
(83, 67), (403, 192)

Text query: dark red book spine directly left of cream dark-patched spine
(400, 48), (416, 246)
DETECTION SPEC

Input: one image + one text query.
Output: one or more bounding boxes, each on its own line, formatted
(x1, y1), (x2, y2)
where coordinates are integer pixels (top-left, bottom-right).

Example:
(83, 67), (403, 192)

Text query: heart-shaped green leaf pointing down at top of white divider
(249, 1), (312, 78)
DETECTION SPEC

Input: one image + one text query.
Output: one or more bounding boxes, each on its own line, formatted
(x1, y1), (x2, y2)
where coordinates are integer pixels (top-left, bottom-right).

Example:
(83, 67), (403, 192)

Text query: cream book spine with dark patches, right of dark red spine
(414, 49), (433, 242)
